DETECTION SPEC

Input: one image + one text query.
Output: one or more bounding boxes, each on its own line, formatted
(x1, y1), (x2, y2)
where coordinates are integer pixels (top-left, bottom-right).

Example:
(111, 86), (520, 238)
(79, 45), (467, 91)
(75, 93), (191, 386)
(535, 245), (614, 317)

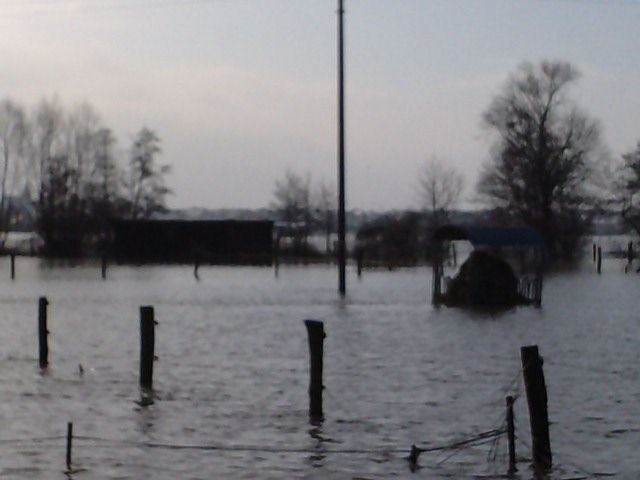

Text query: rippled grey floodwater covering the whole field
(0, 258), (640, 480)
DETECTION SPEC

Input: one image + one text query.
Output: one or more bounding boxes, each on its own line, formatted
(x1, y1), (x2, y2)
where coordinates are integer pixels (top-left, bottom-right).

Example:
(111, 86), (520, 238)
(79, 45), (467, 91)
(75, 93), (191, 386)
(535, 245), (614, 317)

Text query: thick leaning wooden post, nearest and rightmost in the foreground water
(520, 345), (552, 470)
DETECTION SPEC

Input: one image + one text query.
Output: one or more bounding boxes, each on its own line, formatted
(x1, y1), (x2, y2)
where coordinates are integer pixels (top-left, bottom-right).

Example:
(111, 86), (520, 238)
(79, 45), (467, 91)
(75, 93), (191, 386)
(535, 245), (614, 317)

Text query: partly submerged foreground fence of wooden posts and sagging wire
(25, 297), (551, 472)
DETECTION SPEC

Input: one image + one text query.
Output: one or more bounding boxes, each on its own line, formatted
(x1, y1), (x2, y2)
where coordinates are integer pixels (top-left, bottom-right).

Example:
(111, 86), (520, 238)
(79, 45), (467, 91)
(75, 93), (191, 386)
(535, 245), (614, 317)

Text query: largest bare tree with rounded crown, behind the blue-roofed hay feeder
(478, 61), (600, 257)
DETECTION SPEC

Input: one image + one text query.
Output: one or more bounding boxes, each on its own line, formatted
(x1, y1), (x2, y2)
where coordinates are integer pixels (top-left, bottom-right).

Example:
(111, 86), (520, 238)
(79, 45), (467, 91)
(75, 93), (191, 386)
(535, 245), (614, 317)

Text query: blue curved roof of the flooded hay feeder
(432, 225), (545, 247)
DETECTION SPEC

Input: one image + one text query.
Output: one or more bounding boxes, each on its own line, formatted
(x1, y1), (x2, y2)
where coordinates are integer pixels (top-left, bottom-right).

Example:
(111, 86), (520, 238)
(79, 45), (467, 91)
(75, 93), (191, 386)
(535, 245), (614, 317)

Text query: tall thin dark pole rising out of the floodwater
(338, 0), (347, 296)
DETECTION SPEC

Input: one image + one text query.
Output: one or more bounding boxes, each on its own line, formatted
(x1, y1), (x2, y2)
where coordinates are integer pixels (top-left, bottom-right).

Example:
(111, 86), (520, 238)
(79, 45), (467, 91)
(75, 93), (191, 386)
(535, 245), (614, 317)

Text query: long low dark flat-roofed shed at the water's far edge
(110, 220), (273, 264)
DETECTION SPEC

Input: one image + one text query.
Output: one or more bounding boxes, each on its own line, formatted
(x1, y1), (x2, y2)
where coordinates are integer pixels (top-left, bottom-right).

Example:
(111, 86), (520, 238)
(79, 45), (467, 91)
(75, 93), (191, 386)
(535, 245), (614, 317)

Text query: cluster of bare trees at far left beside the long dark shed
(0, 98), (171, 255)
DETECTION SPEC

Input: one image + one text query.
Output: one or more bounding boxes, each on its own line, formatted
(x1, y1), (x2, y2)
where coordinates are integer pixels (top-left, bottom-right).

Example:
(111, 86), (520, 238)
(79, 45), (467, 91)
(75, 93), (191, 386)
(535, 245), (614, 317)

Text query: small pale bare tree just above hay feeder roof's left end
(417, 157), (464, 228)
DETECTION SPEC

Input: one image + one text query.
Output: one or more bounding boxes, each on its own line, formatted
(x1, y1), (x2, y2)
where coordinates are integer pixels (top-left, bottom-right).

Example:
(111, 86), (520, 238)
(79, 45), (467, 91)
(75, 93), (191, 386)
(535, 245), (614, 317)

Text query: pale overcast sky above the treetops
(0, 0), (640, 209)
